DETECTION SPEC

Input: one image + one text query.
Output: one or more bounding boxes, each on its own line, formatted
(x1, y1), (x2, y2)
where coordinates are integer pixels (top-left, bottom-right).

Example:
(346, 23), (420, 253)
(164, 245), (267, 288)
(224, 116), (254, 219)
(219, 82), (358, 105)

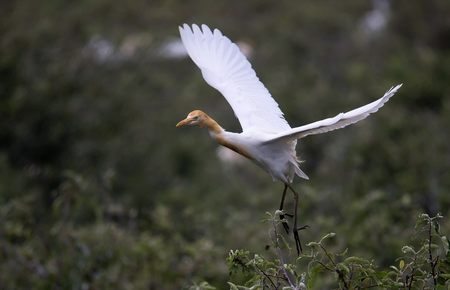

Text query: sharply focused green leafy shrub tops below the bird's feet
(223, 214), (450, 290)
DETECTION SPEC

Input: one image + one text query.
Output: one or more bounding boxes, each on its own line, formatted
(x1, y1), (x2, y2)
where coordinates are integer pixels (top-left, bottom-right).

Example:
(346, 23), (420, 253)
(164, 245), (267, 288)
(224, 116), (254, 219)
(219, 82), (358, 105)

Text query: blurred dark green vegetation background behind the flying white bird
(0, 0), (450, 289)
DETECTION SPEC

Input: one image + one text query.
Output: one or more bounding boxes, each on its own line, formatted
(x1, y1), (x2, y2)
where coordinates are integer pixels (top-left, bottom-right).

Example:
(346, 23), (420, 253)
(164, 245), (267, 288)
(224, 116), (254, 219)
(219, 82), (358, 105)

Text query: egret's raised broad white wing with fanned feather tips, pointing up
(179, 24), (291, 133)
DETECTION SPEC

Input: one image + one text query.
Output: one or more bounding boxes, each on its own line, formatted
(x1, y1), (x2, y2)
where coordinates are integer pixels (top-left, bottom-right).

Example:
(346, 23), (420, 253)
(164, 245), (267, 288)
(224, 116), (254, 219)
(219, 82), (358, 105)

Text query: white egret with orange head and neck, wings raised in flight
(176, 24), (402, 255)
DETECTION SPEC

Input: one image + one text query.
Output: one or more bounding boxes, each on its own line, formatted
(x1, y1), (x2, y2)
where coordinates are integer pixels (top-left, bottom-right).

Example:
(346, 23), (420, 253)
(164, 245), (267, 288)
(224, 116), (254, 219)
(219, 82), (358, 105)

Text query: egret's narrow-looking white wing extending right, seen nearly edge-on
(265, 84), (402, 144)
